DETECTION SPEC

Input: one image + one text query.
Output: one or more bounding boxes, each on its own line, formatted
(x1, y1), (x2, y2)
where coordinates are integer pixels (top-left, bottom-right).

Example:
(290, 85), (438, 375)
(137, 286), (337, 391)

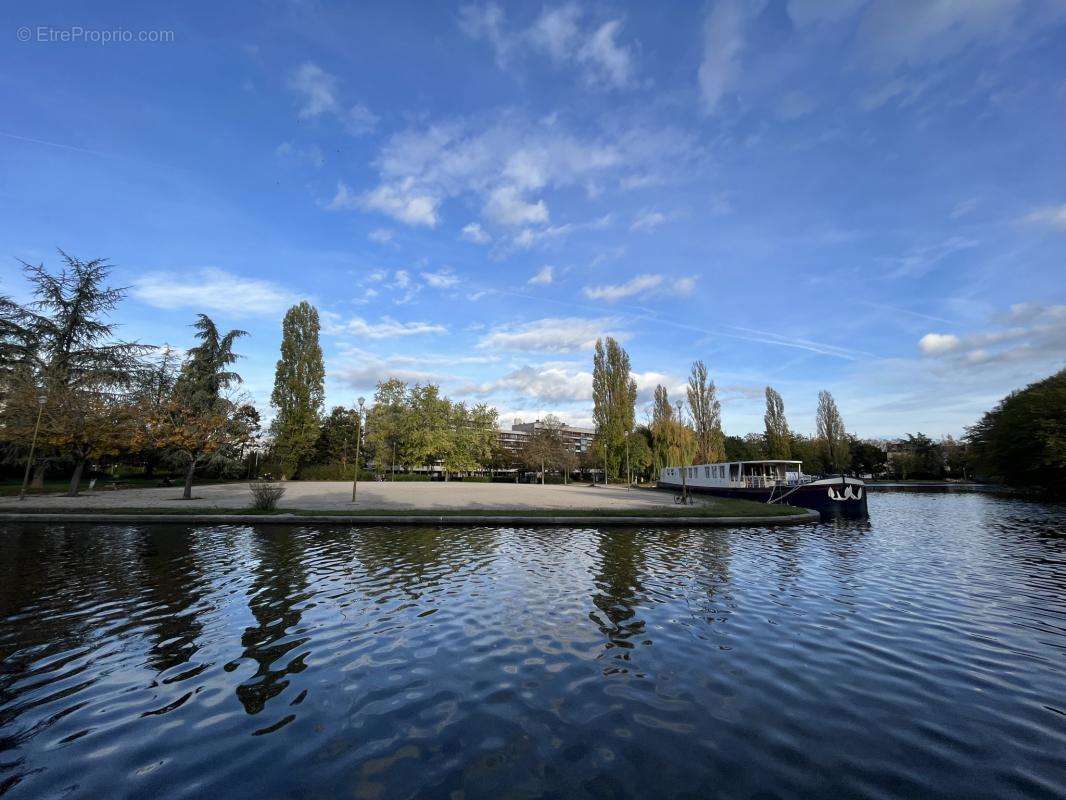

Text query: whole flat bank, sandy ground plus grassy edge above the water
(0, 481), (817, 525)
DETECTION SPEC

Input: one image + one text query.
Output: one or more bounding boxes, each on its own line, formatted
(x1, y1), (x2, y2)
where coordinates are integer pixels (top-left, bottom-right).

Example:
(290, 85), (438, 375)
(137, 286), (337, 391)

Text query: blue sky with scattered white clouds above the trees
(0, 0), (1066, 437)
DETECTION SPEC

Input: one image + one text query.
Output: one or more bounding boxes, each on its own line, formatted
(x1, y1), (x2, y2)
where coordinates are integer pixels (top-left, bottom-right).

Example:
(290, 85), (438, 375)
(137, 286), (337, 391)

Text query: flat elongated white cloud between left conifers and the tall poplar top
(130, 269), (300, 316)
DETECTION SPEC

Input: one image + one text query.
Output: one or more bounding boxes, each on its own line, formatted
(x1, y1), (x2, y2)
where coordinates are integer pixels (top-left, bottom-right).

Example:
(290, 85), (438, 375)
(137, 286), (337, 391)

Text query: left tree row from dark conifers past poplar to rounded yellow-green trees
(0, 257), (497, 498)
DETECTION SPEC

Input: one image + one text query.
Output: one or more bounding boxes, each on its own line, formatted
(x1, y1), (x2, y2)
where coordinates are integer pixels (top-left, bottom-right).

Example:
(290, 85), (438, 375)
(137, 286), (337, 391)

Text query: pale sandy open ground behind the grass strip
(0, 481), (699, 511)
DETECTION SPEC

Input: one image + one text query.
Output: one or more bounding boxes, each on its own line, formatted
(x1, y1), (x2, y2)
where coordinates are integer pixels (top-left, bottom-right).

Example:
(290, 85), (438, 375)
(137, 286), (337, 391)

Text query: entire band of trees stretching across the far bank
(0, 251), (1066, 497)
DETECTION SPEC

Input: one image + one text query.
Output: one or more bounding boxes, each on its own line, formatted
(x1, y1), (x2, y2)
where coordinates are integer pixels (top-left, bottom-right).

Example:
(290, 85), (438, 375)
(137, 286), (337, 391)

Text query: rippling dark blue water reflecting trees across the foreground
(0, 492), (1066, 800)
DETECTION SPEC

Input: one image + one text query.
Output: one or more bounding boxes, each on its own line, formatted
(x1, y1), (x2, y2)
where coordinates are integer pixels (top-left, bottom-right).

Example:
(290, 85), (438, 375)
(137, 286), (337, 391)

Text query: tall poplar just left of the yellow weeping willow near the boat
(593, 336), (636, 480)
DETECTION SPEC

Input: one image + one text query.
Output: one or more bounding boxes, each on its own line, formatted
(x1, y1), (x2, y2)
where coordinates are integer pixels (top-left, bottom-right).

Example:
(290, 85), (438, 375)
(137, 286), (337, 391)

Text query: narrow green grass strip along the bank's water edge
(0, 499), (806, 519)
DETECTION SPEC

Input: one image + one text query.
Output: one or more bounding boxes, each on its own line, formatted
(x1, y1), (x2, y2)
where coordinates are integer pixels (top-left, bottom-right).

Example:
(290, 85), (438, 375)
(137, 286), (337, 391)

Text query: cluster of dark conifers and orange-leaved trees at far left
(0, 251), (259, 498)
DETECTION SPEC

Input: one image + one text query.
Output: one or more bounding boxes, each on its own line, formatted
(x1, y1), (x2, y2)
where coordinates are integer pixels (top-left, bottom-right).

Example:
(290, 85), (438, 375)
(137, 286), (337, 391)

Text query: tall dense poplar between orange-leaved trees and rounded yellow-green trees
(271, 301), (325, 475)
